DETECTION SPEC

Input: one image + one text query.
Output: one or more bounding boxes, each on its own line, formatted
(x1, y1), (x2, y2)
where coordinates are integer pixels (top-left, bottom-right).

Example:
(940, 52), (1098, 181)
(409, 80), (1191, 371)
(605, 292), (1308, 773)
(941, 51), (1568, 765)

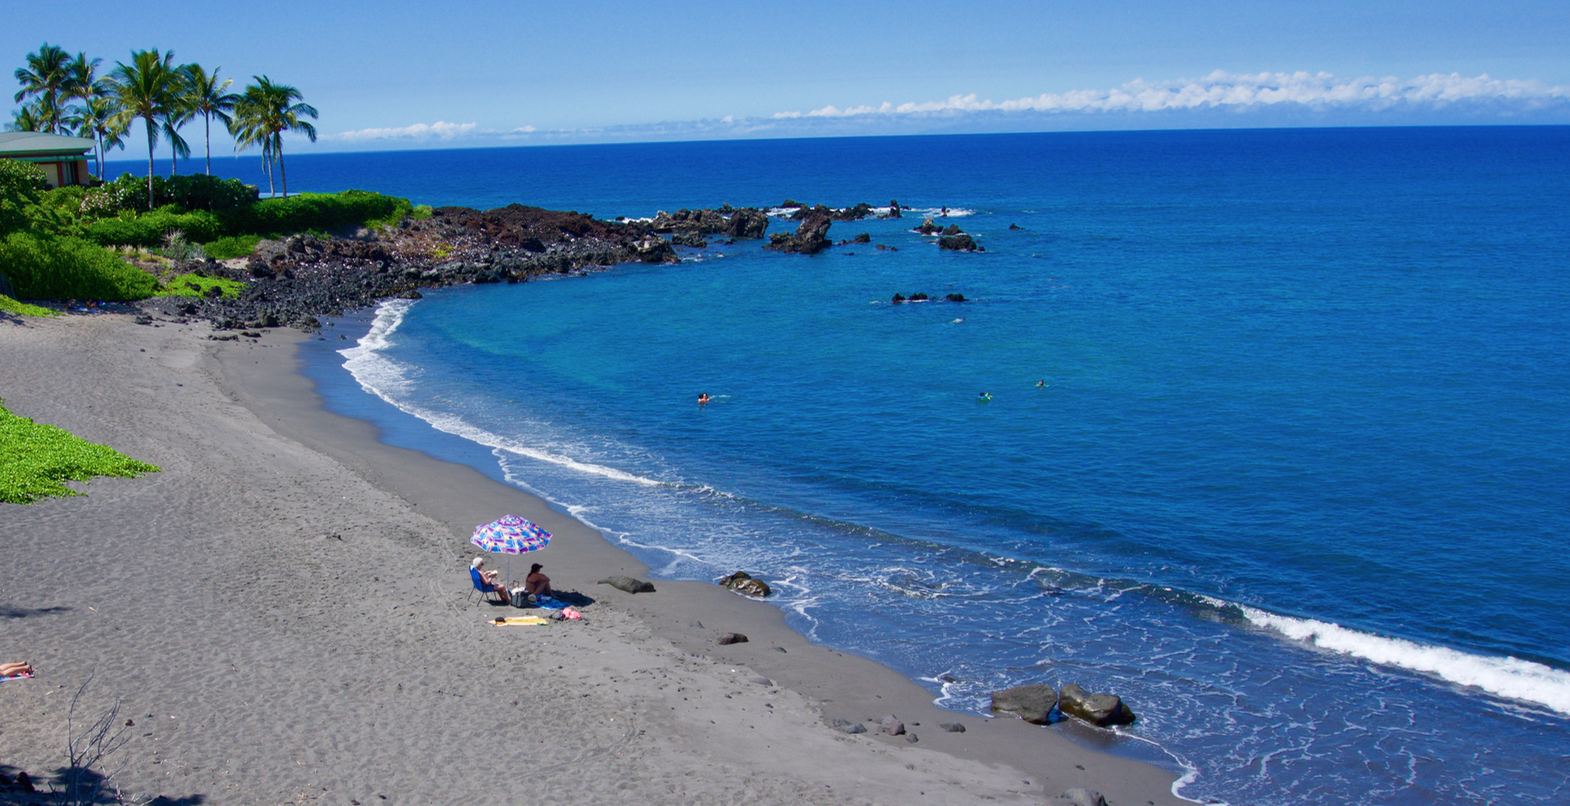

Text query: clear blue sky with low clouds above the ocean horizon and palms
(0, 0), (1570, 159)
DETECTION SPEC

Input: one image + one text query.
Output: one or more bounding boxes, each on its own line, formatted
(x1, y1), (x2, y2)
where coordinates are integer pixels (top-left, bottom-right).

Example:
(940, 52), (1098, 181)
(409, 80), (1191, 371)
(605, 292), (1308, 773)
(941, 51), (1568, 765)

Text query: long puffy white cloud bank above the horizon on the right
(774, 71), (1570, 119)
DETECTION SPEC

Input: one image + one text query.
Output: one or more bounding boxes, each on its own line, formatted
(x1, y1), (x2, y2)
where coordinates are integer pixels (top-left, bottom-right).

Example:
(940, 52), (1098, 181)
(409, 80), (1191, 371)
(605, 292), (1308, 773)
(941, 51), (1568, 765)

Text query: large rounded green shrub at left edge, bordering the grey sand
(0, 233), (157, 300)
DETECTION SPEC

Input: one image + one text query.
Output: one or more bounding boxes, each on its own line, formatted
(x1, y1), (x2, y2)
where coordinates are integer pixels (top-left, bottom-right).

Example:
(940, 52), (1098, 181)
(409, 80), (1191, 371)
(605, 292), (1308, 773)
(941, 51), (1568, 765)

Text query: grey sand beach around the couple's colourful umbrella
(0, 310), (1185, 806)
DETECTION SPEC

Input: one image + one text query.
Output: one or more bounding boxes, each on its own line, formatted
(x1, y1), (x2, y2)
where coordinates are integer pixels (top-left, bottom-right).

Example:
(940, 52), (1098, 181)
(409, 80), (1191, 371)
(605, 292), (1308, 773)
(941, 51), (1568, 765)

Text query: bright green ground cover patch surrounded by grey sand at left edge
(0, 401), (159, 504)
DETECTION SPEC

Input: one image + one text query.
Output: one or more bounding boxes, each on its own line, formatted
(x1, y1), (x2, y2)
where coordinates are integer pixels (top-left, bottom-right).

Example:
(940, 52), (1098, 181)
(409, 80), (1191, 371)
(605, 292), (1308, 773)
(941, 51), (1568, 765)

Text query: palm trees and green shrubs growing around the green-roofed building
(0, 42), (413, 314)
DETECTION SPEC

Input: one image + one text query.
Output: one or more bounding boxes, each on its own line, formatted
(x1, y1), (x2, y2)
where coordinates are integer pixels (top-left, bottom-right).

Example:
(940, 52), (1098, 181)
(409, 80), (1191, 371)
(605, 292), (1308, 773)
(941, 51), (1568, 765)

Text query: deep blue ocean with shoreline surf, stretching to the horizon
(107, 127), (1570, 806)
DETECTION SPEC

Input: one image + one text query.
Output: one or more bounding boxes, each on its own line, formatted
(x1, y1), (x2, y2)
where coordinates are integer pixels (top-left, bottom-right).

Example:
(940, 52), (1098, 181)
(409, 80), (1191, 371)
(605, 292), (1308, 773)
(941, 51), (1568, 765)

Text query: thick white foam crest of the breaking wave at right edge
(1210, 600), (1570, 715)
